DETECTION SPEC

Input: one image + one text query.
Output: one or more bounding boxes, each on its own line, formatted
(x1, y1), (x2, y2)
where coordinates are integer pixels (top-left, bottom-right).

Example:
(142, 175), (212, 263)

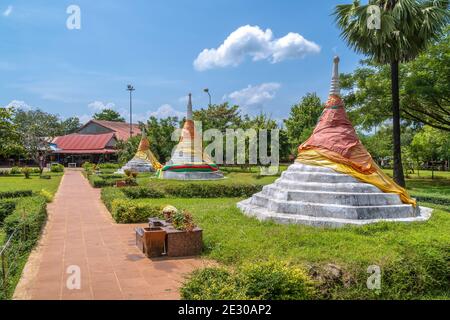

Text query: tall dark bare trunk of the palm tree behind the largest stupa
(391, 61), (406, 187)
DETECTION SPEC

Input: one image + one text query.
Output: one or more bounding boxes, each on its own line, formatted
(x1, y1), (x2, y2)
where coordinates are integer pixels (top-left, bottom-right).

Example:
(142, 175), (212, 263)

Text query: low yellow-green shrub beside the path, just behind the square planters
(111, 199), (163, 223)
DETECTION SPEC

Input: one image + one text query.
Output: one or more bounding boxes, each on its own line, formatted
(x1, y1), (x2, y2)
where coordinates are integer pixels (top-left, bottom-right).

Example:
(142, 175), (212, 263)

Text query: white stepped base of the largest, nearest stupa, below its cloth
(238, 163), (432, 227)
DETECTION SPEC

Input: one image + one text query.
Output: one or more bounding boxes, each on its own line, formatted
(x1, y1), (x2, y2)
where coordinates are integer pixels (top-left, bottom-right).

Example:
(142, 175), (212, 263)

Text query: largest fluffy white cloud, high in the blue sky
(194, 25), (320, 71)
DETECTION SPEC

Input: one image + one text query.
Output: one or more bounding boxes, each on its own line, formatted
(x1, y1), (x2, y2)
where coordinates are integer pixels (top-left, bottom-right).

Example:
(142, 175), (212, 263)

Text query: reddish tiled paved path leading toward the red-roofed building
(14, 170), (206, 300)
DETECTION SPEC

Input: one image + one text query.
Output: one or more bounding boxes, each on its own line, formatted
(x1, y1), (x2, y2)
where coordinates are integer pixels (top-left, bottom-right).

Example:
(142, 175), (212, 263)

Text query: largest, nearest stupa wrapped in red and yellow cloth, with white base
(238, 58), (432, 227)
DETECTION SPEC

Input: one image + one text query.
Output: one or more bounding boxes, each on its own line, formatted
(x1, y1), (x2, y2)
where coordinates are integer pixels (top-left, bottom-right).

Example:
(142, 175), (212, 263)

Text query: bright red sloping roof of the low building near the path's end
(53, 132), (115, 153)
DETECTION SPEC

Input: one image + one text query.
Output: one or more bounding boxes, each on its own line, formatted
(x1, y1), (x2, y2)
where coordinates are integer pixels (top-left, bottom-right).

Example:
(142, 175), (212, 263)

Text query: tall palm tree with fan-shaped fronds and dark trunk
(333, 0), (449, 187)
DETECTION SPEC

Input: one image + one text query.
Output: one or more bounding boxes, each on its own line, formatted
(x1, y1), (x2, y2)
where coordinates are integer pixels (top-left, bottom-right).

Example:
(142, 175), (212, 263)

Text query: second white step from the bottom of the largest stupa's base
(250, 192), (417, 220)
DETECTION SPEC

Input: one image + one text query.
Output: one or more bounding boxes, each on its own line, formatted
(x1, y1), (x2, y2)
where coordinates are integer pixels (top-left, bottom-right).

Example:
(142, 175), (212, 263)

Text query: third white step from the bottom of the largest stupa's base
(262, 185), (402, 206)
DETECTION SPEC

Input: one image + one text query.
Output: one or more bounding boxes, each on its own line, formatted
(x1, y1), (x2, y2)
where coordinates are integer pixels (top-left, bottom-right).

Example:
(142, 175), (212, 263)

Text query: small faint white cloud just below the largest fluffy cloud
(224, 82), (281, 107)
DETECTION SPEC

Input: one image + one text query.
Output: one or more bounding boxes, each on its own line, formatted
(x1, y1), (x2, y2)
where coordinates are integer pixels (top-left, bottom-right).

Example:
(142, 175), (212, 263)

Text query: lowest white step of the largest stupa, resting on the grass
(237, 199), (433, 228)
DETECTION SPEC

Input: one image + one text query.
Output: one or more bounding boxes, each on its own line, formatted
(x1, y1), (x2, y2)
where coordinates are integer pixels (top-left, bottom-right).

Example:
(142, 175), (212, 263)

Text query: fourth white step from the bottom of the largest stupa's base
(273, 179), (381, 193)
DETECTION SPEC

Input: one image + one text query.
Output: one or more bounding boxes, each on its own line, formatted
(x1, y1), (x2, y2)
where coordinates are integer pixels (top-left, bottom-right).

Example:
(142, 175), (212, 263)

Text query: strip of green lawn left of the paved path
(0, 173), (63, 194)
